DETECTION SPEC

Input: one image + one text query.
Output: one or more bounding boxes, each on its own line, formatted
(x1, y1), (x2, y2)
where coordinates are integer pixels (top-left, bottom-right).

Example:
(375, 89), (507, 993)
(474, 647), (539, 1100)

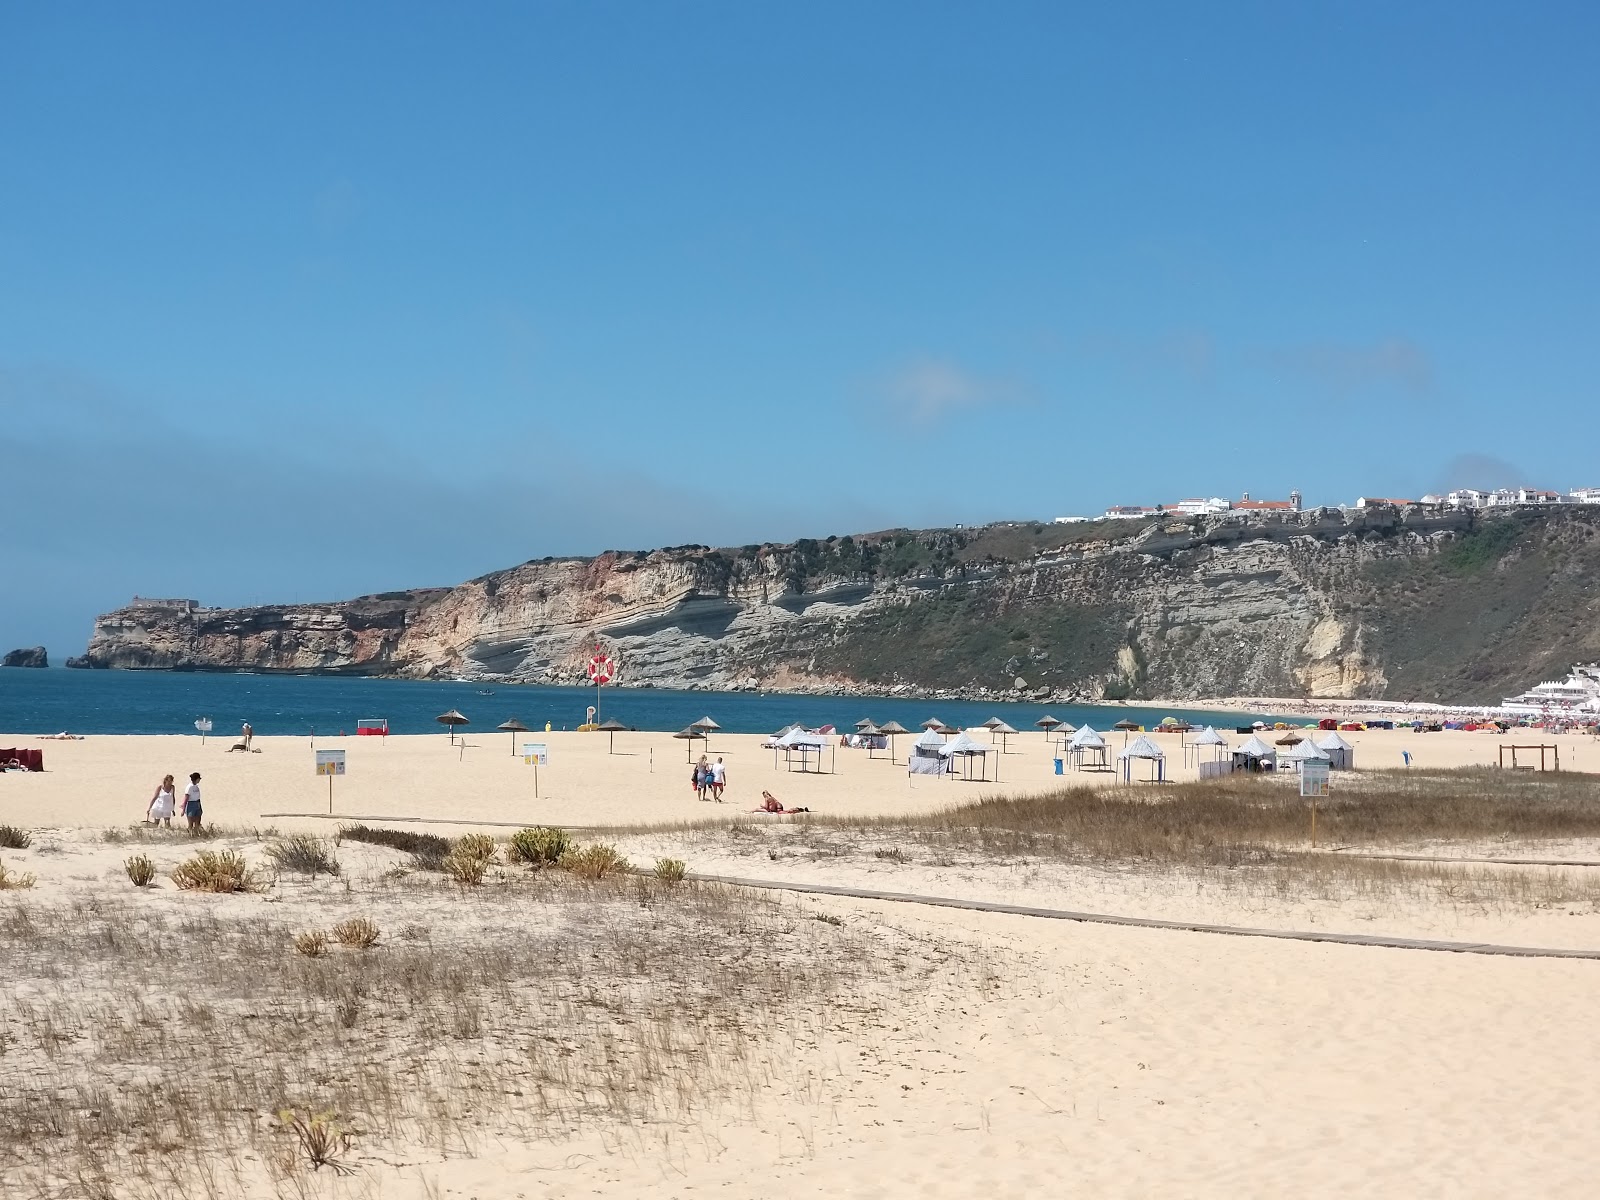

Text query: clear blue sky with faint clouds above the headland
(0, 0), (1600, 656)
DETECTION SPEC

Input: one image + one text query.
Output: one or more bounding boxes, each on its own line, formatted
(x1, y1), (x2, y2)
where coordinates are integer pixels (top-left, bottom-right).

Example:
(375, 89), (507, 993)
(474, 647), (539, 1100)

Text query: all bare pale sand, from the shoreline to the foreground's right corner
(0, 731), (1600, 1200)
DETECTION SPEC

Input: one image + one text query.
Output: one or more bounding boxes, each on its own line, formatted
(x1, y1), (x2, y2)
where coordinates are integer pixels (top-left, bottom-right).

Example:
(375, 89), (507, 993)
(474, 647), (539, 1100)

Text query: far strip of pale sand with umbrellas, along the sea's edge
(0, 730), (1600, 832)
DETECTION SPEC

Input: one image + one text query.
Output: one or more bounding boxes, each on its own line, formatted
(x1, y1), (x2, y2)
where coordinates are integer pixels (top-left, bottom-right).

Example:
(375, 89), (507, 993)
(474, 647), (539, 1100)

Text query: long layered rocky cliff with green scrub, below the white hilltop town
(75, 509), (1600, 699)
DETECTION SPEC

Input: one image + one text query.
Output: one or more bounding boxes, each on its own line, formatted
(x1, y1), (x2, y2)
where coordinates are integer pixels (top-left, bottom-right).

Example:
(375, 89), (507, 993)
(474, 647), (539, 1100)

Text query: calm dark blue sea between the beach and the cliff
(0, 667), (1273, 738)
